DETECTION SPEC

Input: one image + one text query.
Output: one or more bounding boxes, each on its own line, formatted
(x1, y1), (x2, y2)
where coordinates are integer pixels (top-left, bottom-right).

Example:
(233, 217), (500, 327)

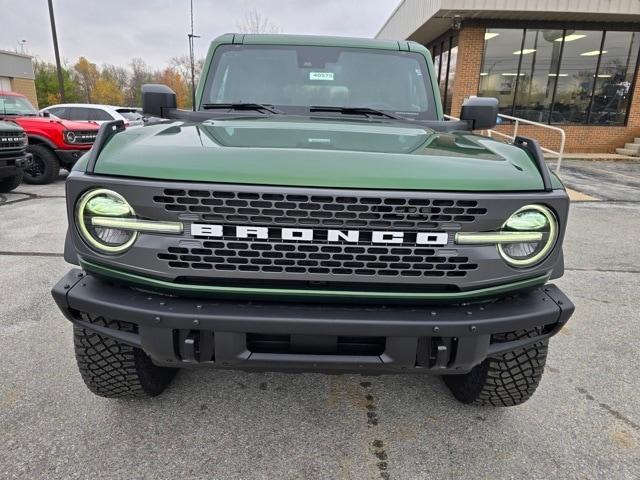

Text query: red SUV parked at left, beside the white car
(0, 91), (99, 185)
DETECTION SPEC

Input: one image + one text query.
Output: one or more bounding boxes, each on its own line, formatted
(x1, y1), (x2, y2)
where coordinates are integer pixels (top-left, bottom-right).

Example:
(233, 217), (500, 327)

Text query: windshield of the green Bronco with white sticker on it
(202, 45), (436, 120)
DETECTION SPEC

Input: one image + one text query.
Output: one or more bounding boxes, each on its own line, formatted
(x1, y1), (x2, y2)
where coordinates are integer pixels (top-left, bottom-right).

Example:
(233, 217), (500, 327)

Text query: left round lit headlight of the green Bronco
(76, 188), (138, 254)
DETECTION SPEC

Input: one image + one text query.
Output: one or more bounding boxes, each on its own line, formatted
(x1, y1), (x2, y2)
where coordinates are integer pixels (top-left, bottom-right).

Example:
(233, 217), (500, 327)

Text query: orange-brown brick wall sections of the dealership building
(451, 27), (640, 153)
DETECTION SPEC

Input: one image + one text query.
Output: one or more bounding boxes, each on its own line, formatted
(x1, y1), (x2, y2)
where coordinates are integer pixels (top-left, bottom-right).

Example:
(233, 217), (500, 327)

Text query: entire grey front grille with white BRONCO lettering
(67, 176), (566, 292)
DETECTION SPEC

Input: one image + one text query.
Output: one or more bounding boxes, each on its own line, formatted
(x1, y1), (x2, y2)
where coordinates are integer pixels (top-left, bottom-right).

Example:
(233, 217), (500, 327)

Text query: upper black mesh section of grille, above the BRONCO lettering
(153, 189), (487, 230)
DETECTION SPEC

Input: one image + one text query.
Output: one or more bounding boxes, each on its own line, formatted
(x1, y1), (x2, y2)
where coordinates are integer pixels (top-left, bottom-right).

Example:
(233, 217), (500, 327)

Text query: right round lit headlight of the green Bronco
(498, 205), (558, 267)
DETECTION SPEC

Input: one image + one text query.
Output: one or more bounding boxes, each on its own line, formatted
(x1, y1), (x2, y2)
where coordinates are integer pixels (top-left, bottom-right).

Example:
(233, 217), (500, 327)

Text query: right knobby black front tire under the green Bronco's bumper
(443, 329), (549, 407)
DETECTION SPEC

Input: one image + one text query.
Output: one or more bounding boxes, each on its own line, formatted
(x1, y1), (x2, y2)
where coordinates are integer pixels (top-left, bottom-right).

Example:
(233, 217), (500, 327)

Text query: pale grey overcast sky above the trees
(0, 0), (399, 68)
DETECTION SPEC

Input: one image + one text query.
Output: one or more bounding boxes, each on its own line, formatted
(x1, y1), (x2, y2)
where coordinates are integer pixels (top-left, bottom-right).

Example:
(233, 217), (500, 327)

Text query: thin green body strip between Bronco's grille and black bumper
(80, 261), (549, 302)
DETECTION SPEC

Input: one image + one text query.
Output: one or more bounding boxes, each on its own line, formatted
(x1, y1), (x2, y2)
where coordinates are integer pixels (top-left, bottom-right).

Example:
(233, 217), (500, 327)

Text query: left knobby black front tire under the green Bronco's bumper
(73, 315), (177, 398)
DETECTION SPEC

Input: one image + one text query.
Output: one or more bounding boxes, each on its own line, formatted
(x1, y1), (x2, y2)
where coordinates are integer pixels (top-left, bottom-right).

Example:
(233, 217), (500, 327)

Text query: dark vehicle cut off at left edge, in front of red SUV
(0, 121), (30, 193)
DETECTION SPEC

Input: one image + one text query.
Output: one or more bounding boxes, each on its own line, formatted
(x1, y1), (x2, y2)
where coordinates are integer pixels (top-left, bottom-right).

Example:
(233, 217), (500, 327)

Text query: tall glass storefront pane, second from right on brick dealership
(551, 30), (602, 123)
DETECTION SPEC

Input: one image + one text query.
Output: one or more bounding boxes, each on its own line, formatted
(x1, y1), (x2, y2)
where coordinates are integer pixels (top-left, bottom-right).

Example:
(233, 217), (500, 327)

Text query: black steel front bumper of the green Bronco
(52, 269), (574, 373)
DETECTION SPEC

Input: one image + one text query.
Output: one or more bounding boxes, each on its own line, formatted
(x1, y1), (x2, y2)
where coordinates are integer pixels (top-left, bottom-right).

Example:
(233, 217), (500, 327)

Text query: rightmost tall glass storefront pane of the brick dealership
(589, 32), (640, 125)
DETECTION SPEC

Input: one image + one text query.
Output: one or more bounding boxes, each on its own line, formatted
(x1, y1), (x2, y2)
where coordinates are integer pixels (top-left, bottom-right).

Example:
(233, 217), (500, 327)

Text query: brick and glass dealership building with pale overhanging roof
(377, 0), (640, 153)
